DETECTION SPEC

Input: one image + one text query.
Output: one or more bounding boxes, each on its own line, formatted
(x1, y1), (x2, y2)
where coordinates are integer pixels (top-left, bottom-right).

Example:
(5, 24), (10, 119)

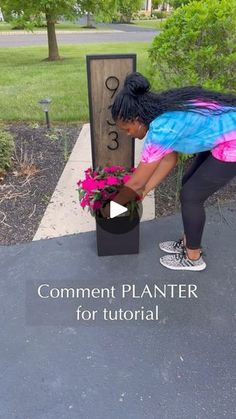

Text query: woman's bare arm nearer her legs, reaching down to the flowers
(143, 152), (178, 198)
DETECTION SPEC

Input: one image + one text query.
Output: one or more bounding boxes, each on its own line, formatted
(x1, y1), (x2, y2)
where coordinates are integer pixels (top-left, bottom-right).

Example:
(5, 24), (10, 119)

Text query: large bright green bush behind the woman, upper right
(149, 0), (236, 91)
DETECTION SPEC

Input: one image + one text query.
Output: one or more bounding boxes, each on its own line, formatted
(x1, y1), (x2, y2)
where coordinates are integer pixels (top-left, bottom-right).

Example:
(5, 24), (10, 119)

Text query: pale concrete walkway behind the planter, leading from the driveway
(33, 124), (155, 240)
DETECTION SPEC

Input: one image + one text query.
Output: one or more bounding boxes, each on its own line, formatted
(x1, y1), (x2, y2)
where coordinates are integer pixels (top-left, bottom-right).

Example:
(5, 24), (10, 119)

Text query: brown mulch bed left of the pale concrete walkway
(0, 123), (81, 245)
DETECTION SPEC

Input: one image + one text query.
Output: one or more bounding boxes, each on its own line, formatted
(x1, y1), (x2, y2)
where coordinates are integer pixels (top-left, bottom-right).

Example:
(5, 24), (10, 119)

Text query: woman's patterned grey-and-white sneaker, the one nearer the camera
(160, 250), (206, 271)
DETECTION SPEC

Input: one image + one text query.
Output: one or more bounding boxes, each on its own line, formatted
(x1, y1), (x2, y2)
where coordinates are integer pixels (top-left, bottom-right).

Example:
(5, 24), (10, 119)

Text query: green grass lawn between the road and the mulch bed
(0, 42), (149, 122)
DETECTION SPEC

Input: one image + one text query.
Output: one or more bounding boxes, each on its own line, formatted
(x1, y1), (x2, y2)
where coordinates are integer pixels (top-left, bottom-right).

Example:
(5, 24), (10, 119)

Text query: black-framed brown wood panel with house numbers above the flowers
(86, 54), (136, 168)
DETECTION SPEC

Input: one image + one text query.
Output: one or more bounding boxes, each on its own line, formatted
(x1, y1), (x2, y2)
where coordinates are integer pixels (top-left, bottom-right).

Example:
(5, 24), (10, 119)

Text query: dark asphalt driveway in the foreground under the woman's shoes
(0, 202), (236, 419)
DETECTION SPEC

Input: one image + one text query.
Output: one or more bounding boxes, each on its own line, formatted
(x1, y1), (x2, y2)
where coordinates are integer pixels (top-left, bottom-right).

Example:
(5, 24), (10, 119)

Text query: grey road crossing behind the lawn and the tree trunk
(0, 25), (159, 47)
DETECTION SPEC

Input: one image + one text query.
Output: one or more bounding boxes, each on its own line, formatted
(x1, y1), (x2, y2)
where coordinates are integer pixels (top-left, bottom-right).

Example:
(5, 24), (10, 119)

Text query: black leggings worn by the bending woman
(180, 151), (236, 249)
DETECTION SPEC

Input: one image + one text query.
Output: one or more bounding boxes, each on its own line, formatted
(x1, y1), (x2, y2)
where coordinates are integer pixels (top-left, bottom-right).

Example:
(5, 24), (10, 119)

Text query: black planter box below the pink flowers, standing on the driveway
(96, 214), (140, 256)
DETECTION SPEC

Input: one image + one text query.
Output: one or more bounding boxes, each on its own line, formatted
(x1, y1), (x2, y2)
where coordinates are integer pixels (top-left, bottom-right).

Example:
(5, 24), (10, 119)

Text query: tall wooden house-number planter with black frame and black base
(86, 54), (139, 256)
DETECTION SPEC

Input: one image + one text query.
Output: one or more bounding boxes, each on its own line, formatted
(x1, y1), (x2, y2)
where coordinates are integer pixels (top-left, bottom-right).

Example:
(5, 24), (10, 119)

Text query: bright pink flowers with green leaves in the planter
(77, 166), (139, 216)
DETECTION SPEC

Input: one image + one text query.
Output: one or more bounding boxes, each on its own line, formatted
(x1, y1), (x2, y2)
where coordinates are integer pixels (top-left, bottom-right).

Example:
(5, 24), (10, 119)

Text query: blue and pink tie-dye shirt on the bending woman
(141, 101), (236, 163)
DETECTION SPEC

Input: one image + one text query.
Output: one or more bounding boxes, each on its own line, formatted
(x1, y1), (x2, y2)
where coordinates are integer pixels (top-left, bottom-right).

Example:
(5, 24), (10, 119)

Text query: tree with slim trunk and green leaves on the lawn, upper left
(1, 0), (78, 61)
